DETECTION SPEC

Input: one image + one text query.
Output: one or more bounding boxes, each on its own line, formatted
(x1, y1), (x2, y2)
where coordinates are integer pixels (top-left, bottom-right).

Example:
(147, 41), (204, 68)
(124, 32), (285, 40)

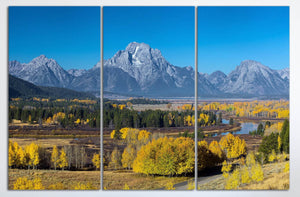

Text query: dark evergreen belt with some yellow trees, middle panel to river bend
(103, 103), (218, 130)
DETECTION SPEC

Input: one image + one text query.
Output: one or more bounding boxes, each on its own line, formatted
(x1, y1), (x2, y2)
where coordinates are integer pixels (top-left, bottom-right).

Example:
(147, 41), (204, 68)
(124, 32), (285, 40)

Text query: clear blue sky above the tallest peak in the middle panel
(103, 7), (195, 67)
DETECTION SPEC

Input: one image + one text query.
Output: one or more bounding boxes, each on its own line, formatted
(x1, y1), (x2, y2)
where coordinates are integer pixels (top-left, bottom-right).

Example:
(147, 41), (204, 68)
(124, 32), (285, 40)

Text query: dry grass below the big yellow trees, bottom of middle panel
(103, 170), (194, 190)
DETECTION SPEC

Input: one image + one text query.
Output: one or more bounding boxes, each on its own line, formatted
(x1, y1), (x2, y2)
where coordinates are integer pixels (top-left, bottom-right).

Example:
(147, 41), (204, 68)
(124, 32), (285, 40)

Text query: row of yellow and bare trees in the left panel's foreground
(8, 140), (100, 170)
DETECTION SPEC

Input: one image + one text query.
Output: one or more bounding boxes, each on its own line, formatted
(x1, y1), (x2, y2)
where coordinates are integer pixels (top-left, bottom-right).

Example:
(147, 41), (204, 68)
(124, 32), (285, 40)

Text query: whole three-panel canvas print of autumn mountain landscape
(7, 6), (290, 191)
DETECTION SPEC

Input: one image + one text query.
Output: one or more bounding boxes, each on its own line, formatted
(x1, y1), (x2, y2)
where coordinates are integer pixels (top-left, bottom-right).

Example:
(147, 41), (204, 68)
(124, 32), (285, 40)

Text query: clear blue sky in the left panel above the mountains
(9, 7), (100, 69)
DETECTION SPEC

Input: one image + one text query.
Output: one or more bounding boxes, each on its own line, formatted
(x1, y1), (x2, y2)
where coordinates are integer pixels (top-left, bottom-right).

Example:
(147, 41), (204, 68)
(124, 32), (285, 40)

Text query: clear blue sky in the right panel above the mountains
(198, 7), (289, 74)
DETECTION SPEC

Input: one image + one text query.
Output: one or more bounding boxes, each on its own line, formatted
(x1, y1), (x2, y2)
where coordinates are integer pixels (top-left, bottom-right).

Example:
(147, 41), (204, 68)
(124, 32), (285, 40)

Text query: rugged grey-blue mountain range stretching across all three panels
(9, 42), (289, 97)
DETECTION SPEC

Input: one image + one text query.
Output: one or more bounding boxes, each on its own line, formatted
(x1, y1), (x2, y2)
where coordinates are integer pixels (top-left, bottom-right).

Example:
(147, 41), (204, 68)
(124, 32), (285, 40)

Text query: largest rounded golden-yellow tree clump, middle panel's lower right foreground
(133, 137), (195, 175)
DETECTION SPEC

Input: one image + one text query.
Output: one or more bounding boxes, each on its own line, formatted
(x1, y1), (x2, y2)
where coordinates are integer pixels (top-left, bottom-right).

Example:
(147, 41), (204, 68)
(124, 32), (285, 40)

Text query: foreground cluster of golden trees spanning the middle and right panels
(107, 128), (247, 176)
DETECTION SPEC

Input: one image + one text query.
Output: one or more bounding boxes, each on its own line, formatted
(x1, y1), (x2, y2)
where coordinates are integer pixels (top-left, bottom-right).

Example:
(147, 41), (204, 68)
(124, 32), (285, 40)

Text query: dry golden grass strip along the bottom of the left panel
(8, 169), (100, 190)
